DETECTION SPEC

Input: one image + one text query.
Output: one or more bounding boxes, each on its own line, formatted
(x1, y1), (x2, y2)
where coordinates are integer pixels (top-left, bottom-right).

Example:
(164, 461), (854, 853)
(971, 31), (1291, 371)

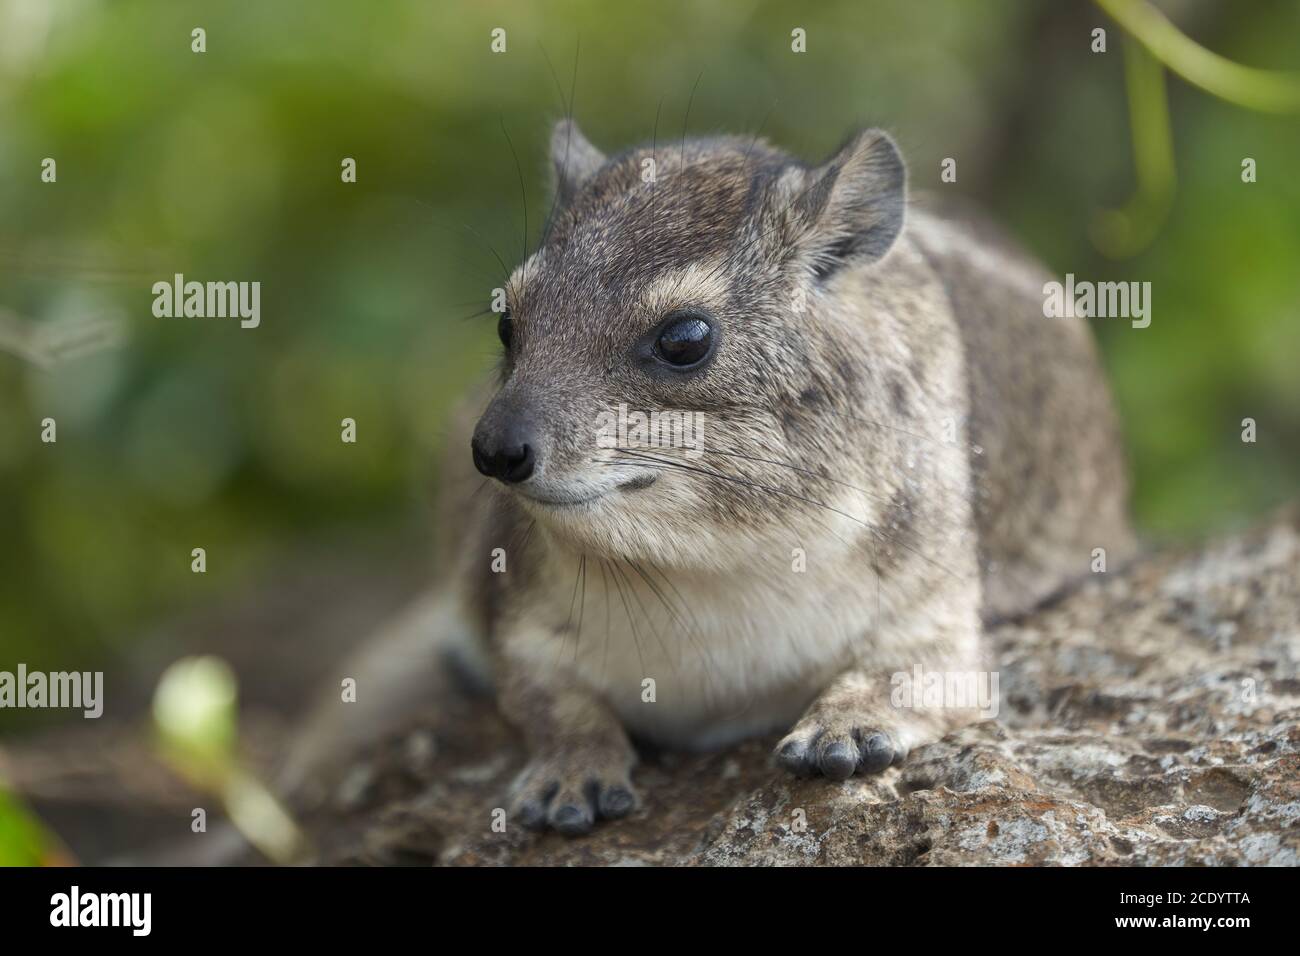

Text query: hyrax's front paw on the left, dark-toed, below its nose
(510, 753), (640, 836)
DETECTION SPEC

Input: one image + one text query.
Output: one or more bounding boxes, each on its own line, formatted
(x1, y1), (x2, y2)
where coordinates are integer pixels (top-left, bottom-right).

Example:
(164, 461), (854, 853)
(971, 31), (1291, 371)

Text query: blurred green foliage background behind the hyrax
(0, 0), (1300, 861)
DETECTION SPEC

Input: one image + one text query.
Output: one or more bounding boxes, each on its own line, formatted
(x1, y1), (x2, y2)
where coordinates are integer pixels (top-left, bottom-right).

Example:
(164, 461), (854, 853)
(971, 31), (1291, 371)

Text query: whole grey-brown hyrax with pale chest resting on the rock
(443, 121), (1131, 834)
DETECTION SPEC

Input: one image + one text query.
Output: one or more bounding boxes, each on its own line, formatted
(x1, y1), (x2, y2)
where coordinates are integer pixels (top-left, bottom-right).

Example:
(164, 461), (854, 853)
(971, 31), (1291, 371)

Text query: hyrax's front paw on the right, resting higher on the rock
(776, 715), (907, 780)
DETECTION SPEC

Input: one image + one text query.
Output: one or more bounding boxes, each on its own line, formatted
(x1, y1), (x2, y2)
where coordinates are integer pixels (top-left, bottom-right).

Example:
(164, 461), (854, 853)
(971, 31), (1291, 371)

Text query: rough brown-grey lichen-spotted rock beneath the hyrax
(297, 511), (1300, 866)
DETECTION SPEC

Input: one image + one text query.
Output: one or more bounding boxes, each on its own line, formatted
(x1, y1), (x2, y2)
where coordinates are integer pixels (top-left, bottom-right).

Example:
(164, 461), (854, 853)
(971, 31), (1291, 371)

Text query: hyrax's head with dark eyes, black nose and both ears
(472, 121), (905, 568)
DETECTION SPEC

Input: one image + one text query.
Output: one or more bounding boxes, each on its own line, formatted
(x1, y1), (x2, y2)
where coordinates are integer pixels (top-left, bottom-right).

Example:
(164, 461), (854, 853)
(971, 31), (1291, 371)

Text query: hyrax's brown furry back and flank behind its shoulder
(910, 209), (1134, 618)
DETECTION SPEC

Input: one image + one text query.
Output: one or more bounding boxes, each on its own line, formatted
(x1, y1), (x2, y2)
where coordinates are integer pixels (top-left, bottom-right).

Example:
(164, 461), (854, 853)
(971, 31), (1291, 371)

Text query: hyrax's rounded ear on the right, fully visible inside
(792, 130), (907, 276)
